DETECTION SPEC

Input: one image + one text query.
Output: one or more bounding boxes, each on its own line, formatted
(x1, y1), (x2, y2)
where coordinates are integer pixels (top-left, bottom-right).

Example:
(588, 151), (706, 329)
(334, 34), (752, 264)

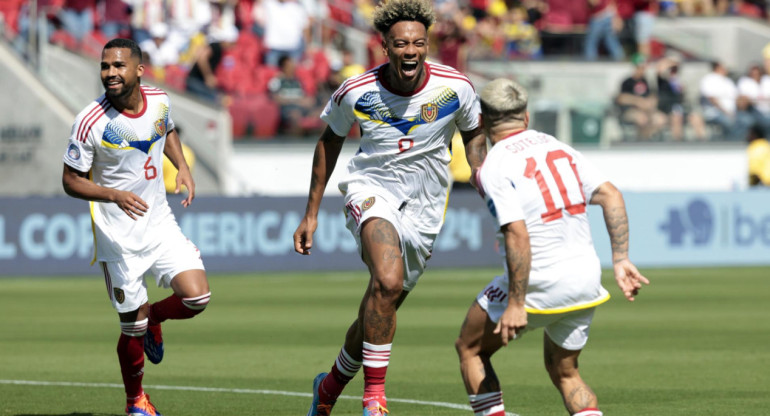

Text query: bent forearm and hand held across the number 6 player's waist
(62, 163), (150, 220)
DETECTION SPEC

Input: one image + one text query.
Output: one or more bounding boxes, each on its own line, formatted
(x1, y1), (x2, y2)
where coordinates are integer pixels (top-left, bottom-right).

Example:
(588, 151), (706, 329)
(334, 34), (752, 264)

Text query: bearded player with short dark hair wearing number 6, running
(62, 39), (211, 416)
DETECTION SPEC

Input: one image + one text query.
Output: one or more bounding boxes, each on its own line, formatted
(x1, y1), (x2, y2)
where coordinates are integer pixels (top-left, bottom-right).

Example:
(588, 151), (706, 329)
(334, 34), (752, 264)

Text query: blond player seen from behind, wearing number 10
(456, 79), (649, 416)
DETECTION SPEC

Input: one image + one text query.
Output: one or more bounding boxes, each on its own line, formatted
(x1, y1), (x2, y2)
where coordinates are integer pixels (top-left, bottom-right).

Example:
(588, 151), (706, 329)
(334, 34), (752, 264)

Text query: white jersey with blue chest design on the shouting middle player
(321, 62), (481, 233)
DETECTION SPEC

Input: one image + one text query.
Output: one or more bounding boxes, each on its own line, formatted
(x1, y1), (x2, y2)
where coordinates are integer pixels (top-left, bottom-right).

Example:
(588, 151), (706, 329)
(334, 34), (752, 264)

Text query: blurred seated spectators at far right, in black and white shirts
(615, 45), (770, 141)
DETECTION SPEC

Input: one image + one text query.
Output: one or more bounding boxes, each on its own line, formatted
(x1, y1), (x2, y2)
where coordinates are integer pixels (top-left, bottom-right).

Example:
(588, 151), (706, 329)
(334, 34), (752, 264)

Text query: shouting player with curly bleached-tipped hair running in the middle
(294, 0), (486, 416)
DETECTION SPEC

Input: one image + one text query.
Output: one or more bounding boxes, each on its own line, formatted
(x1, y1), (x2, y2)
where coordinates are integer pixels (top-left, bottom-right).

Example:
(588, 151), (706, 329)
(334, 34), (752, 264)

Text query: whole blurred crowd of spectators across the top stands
(0, 0), (770, 140)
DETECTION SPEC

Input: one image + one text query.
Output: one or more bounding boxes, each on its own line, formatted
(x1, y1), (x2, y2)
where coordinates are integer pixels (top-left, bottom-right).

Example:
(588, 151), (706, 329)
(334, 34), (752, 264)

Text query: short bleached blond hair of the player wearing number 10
(479, 78), (528, 124)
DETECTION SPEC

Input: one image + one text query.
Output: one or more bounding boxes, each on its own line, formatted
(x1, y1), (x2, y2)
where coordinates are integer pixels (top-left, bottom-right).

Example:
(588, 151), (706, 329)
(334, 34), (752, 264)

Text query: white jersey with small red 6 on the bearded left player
(63, 85), (178, 261)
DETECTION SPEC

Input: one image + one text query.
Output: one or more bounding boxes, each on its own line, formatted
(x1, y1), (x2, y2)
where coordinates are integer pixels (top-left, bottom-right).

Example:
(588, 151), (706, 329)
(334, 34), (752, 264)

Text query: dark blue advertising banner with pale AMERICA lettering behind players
(0, 192), (499, 276)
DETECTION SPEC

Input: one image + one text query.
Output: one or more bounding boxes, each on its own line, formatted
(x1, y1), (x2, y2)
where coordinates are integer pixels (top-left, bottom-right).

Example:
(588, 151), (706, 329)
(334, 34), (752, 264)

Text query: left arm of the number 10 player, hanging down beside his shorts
(494, 220), (532, 345)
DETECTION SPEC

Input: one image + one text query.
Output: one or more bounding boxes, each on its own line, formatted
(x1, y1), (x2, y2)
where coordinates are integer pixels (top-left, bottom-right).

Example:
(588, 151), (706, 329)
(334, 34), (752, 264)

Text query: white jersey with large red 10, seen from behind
(479, 130), (608, 311)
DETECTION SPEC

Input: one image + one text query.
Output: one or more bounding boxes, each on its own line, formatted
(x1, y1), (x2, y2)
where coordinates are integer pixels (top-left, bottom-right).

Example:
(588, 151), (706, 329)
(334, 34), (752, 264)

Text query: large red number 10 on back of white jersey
(524, 150), (586, 222)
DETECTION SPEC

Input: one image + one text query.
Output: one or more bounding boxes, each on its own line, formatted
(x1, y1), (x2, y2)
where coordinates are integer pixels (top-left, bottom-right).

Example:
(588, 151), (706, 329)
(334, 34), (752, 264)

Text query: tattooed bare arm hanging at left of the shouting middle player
(294, 126), (345, 255)
